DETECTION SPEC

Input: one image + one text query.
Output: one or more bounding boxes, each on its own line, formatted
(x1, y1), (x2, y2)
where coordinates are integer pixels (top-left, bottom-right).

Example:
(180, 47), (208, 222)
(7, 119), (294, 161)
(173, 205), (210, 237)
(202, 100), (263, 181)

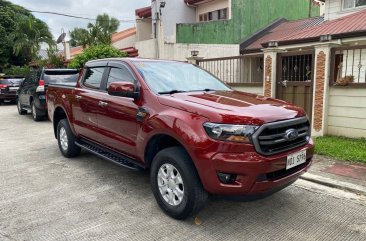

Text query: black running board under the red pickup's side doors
(75, 140), (144, 171)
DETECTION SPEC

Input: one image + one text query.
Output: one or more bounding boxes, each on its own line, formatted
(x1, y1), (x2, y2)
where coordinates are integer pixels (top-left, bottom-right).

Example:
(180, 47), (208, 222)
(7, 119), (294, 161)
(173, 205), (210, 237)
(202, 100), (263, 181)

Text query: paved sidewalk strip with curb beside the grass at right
(301, 155), (366, 196)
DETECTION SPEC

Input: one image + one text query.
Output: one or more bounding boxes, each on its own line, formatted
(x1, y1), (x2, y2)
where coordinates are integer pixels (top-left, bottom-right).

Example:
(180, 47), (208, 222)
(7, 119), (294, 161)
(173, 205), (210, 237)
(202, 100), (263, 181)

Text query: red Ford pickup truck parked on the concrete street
(47, 58), (314, 219)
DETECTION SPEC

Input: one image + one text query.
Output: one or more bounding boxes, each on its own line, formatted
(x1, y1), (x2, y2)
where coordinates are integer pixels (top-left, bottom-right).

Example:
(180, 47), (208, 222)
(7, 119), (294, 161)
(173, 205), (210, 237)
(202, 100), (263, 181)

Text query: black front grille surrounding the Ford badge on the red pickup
(252, 117), (310, 156)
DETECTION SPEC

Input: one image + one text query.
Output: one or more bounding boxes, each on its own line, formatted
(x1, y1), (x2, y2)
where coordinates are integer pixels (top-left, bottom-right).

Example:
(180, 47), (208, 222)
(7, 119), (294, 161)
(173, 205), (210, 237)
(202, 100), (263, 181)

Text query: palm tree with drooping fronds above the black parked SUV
(11, 16), (54, 57)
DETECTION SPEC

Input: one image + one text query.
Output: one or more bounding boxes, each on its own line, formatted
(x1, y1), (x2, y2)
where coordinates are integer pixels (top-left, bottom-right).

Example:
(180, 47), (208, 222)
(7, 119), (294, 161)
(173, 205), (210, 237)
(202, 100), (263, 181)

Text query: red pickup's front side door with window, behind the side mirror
(98, 62), (138, 157)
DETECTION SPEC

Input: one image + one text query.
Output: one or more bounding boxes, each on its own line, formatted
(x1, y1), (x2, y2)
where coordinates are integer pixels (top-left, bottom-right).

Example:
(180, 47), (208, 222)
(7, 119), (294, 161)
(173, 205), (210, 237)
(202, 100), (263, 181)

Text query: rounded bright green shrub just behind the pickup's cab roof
(68, 45), (127, 69)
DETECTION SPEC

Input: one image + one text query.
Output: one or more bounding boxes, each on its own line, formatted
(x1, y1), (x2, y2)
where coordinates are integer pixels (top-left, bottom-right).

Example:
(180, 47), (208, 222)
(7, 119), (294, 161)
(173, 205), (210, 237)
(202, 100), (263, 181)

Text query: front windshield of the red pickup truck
(134, 61), (231, 94)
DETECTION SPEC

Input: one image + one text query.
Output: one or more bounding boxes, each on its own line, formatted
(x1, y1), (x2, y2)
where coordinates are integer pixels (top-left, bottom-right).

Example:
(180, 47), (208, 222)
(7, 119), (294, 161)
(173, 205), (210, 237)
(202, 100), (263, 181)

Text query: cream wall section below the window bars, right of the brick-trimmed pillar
(328, 87), (366, 138)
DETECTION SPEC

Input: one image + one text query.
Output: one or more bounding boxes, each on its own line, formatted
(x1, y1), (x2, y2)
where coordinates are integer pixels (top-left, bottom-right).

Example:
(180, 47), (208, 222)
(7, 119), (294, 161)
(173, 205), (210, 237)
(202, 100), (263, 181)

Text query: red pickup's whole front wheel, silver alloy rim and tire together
(150, 147), (208, 219)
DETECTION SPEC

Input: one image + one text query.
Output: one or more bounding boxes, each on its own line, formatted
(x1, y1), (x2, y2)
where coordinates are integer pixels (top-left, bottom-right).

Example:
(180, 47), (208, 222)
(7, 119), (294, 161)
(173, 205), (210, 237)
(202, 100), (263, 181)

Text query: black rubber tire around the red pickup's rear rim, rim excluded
(57, 119), (81, 158)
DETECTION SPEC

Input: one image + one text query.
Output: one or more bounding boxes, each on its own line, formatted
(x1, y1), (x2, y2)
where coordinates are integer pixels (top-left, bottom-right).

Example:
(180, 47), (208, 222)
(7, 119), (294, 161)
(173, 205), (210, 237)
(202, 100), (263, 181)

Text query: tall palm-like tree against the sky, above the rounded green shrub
(70, 13), (119, 48)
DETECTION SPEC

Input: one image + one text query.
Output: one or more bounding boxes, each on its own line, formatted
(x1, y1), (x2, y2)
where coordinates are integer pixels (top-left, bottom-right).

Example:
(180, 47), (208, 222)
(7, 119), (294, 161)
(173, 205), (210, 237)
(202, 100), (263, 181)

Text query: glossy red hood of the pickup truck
(159, 91), (306, 125)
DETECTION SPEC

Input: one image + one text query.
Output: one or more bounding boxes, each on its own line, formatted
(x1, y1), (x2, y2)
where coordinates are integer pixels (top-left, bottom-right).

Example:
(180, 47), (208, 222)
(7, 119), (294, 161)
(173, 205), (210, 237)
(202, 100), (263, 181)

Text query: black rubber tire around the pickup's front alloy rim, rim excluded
(150, 147), (208, 219)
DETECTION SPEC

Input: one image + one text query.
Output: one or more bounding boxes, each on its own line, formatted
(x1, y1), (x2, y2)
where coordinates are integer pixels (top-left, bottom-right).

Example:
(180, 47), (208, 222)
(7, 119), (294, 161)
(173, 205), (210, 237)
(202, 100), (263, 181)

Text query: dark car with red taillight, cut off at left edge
(0, 76), (24, 103)
